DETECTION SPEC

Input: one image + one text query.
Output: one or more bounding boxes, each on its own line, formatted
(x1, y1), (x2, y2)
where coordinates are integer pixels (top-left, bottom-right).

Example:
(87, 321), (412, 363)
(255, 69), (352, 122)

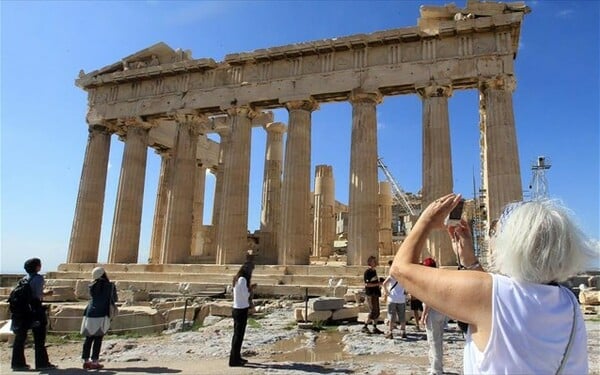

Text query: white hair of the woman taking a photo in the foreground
(491, 199), (598, 284)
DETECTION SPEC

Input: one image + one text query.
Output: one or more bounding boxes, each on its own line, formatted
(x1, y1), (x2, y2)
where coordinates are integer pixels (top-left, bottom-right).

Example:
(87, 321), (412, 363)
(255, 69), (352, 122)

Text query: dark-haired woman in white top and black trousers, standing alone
(229, 262), (256, 367)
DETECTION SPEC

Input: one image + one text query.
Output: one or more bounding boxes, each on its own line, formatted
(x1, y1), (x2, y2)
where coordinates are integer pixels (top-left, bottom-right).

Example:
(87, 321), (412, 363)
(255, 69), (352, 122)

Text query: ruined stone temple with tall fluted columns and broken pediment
(67, 0), (528, 266)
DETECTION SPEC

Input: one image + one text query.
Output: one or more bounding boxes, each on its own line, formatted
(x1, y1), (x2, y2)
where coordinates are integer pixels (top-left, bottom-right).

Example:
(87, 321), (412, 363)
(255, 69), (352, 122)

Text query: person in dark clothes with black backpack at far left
(11, 258), (56, 371)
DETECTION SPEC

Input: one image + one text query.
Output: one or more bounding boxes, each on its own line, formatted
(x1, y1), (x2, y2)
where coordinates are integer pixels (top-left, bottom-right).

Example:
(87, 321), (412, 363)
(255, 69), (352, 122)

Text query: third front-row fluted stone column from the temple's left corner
(162, 114), (205, 264)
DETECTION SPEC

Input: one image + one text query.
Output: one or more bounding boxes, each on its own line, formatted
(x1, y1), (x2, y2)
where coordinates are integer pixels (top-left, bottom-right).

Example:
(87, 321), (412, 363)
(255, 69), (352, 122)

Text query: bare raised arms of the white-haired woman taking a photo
(390, 194), (492, 342)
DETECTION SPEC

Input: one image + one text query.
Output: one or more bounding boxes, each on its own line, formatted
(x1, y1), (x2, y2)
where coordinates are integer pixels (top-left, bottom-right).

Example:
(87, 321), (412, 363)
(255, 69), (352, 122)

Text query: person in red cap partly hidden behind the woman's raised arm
(421, 258), (446, 375)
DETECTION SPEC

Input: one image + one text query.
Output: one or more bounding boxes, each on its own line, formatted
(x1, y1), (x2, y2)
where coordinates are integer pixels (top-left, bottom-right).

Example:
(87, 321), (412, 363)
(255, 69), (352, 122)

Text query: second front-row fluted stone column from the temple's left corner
(108, 119), (149, 263)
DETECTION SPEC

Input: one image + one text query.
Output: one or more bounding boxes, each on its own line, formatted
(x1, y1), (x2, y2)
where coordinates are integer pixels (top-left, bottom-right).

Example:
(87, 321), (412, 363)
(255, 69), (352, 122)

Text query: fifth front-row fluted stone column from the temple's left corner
(277, 100), (318, 265)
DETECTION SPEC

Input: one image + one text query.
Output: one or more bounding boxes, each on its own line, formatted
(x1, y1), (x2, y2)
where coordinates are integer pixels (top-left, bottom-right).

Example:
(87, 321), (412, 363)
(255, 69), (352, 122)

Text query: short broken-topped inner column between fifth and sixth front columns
(313, 165), (335, 257)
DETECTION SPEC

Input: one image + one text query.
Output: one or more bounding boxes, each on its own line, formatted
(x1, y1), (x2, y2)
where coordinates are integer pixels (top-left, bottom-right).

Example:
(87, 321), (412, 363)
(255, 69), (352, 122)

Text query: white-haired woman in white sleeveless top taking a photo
(391, 194), (598, 374)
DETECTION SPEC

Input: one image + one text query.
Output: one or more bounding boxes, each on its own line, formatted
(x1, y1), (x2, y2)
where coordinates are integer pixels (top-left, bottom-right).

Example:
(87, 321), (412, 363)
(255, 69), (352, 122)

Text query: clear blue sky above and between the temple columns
(0, 0), (600, 273)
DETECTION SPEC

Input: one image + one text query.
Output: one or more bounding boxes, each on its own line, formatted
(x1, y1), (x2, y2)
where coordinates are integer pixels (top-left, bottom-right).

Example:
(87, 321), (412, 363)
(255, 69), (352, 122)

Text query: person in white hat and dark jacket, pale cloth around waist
(81, 267), (118, 370)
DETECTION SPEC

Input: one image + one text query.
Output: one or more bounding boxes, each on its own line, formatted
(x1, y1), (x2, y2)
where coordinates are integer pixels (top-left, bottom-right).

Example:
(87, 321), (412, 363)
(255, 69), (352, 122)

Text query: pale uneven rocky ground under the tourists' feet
(0, 303), (600, 375)
